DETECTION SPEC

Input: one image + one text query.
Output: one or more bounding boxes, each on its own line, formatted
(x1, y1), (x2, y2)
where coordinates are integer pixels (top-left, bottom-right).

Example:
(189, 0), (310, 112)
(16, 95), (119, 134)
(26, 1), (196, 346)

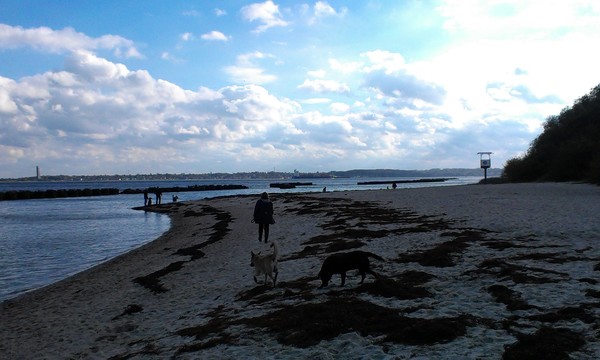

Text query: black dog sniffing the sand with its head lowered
(319, 251), (383, 288)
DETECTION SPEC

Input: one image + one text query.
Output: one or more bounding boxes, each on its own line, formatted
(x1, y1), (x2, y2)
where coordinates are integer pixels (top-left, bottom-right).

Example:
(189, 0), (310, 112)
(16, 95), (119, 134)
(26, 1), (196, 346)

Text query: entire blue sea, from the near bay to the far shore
(0, 177), (481, 302)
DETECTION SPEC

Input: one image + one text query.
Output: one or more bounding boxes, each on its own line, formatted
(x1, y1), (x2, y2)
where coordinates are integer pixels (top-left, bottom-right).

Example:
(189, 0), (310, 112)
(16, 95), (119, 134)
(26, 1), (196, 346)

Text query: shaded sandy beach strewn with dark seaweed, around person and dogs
(0, 183), (600, 359)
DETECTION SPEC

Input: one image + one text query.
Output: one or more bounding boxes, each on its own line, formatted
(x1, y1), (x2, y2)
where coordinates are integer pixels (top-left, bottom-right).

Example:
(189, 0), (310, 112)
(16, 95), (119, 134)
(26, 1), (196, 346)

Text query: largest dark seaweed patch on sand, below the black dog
(240, 297), (470, 348)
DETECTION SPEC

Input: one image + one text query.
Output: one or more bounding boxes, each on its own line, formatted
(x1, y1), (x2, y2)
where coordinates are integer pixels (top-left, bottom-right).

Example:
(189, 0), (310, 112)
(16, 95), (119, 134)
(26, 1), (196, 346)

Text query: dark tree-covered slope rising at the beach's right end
(503, 85), (600, 184)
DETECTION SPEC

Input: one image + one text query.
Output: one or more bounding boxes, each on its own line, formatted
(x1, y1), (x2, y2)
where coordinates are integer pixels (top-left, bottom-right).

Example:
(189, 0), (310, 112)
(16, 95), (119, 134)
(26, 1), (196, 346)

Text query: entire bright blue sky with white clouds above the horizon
(0, 0), (600, 178)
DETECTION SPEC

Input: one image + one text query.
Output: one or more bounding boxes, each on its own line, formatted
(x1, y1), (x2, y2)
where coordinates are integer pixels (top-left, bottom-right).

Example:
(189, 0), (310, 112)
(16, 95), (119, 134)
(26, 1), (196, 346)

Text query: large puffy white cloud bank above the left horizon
(0, 52), (300, 173)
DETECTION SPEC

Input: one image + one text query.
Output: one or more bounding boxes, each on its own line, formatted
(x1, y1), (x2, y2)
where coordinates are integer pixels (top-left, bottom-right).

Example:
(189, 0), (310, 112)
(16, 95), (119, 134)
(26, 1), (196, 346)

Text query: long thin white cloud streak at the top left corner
(0, 24), (141, 57)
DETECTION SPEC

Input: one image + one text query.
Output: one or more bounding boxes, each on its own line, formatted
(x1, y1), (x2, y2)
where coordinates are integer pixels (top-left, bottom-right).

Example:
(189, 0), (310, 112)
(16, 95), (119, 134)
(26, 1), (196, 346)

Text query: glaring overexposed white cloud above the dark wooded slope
(434, 0), (600, 114)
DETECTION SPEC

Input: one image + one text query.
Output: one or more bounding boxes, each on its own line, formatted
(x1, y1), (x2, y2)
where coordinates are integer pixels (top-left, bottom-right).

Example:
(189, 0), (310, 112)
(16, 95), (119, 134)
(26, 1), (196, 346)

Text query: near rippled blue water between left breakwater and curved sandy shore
(0, 195), (170, 300)
